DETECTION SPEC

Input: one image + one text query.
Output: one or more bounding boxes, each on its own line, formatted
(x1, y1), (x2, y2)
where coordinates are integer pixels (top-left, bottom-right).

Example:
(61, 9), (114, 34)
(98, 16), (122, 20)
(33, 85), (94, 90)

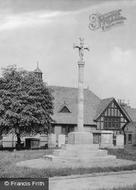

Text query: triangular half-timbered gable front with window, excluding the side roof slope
(96, 99), (129, 130)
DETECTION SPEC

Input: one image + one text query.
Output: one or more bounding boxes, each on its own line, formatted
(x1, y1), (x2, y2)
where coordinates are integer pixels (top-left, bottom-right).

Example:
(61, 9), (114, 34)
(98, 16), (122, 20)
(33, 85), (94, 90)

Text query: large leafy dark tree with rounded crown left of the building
(0, 66), (53, 145)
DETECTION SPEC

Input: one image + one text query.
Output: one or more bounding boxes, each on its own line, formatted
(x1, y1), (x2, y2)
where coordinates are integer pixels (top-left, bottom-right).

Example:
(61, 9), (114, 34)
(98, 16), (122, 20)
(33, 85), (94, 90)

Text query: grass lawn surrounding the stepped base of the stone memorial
(0, 149), (136, 178)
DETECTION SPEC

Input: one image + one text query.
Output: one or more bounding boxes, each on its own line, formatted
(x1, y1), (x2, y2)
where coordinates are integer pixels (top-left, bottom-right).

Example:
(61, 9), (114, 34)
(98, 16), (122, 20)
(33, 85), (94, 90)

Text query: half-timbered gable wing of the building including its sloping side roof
(94, 98), (130, 130)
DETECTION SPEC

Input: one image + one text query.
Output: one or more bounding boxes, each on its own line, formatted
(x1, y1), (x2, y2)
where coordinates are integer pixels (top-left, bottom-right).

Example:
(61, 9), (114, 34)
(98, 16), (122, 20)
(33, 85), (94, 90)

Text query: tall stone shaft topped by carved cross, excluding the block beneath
(74, 38), (89, 132)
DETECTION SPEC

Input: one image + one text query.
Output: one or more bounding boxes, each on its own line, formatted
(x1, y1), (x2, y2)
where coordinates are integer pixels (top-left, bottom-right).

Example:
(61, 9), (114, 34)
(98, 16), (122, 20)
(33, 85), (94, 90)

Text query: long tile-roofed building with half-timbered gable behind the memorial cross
(35, 67), (136, 148)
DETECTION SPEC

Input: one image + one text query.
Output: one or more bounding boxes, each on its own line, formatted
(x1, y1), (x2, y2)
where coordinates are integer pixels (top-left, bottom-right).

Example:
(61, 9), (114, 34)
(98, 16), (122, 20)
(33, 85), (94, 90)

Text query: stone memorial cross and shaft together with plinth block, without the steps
(68, 38), (93, 145)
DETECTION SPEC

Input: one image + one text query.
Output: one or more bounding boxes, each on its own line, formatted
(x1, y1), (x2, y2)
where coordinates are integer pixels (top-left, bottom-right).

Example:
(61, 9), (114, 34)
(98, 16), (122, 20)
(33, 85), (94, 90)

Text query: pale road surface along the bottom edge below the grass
(49, 171), (136, 190)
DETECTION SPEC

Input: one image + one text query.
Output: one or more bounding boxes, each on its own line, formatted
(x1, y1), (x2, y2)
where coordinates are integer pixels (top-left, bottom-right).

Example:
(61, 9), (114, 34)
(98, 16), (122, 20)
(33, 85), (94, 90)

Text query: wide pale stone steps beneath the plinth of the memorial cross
(44, 144), (116, 162)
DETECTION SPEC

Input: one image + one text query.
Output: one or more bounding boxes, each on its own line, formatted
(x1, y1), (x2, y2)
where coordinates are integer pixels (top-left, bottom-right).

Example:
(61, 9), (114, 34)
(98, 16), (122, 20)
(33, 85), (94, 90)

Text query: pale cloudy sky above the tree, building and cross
(0, 0), (136, 107)
